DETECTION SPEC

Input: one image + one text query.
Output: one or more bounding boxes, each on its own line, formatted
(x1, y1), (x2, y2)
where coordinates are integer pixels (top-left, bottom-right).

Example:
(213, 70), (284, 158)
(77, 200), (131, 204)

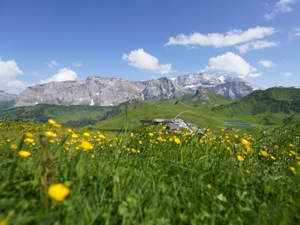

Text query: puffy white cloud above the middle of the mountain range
(122, 48), (172, 74)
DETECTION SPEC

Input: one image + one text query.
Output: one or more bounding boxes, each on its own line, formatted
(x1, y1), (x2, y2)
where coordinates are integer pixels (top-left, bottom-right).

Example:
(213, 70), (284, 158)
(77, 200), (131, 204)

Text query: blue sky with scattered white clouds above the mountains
(0, 0), (300, 92)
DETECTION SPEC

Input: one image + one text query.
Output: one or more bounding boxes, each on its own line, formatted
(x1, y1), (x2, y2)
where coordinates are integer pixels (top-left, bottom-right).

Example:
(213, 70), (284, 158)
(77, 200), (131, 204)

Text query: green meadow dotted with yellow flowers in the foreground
(0, 120), (300, 225)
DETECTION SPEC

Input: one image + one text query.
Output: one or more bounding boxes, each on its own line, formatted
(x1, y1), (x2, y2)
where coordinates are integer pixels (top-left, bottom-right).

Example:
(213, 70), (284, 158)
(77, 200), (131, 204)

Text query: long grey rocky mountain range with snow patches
(15, 73), (256, 106)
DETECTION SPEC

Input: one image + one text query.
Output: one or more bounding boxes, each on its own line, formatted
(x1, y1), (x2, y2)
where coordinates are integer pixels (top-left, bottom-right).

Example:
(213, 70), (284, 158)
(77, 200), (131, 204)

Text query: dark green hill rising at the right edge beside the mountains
(213, 87), (300, 116)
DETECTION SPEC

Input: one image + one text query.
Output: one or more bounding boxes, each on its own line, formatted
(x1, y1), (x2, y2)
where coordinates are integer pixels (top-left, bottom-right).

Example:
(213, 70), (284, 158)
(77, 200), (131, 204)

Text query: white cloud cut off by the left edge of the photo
(0, 58), (28, 93)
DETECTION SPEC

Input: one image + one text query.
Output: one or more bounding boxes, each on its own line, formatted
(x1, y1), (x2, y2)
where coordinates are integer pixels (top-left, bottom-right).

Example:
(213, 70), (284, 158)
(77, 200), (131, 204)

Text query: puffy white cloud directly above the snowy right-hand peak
(206, 52), (261, 78)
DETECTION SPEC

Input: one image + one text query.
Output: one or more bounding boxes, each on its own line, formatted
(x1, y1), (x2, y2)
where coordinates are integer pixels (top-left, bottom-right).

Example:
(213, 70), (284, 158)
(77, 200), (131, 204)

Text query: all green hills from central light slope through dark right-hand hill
(96, 88), (300, 129)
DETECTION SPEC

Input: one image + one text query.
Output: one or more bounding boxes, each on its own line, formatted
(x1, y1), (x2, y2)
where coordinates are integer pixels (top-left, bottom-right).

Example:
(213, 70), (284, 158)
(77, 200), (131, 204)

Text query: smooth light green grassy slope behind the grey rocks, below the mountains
(95, 101), (285, 129)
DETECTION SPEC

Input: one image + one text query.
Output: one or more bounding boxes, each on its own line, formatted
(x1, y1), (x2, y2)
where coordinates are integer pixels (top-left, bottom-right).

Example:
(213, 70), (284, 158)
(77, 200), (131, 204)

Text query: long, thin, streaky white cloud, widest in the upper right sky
(166, 26), (276, 48)
